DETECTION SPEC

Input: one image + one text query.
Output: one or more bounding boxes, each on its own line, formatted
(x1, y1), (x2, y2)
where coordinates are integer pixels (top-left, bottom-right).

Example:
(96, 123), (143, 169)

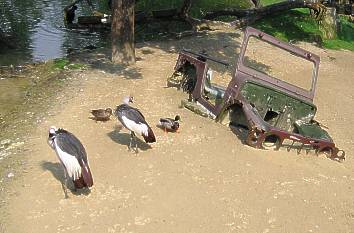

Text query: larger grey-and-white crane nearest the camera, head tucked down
(48, 126), (93, 197)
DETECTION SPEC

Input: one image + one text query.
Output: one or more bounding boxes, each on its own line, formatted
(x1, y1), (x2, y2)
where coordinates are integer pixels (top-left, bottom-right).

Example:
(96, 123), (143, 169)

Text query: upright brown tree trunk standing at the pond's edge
(111, 0), (135, 65)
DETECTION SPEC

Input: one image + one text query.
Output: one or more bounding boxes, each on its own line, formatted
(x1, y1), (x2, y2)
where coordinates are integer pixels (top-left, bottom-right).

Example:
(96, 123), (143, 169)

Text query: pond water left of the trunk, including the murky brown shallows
(0, 0), (109, 123)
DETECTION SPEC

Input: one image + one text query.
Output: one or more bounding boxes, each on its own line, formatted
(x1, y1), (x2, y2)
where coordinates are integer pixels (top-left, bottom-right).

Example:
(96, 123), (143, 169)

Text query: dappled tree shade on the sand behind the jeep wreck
(68, 29), (246, 80)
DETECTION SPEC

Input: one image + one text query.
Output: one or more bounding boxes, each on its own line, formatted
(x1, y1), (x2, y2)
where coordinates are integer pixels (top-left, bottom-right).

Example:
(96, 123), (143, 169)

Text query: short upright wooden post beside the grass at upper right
(319, 7), (337, 39)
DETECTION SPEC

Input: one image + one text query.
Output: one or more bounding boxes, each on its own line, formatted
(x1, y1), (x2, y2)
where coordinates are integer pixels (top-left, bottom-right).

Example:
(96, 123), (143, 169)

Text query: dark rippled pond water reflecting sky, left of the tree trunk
(0, 0), (109, 66)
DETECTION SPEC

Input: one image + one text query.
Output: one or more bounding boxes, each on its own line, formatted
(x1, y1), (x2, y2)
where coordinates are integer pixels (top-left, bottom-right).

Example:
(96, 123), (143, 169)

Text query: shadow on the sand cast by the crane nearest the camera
(41, 161), (91, 196)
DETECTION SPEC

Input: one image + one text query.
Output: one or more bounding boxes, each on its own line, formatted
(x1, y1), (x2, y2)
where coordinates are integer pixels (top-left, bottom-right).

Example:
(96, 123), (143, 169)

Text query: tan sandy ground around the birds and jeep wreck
(0, 29), (354, 233)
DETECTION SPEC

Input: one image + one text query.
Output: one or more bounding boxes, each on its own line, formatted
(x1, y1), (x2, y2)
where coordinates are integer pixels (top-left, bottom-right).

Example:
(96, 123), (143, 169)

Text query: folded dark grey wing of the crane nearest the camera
(56, 129), (87, 164)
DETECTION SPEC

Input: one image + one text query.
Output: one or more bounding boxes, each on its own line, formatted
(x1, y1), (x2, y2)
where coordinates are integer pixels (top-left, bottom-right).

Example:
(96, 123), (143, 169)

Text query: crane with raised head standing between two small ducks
(114, 97), (156, 153)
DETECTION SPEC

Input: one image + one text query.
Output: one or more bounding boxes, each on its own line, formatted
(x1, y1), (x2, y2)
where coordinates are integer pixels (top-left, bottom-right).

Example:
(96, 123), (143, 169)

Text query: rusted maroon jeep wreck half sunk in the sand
(167, 27), (345, 161)
